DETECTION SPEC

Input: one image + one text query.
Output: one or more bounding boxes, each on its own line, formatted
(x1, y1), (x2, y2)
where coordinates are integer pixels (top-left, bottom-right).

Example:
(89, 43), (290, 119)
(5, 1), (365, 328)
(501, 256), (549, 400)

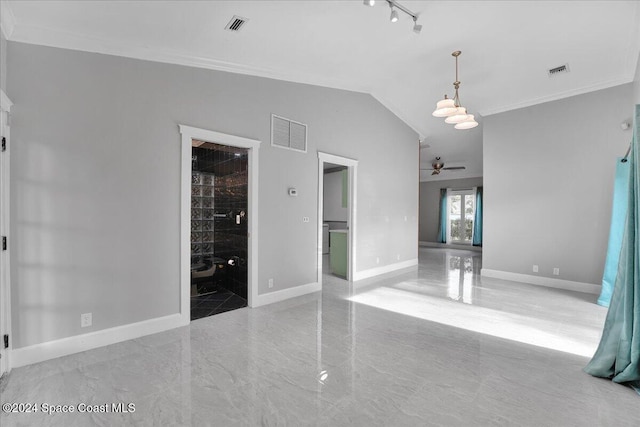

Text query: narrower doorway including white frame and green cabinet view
(318, 152), (358, 283)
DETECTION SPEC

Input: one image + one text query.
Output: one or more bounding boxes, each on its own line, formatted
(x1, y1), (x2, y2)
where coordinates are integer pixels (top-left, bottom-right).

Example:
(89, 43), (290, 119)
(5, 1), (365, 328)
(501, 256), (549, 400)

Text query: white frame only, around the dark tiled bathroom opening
(180, 125), (260, 324)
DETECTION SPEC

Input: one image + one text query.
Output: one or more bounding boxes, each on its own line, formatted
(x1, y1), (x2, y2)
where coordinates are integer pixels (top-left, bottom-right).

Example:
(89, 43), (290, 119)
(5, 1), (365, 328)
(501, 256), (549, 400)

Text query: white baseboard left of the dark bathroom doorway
(11, 313), (189, 368)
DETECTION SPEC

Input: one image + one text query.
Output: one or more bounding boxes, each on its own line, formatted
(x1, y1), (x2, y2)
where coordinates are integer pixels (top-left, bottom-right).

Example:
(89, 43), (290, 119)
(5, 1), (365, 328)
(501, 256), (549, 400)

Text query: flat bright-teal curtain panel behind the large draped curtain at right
(598, 159), (629, 307)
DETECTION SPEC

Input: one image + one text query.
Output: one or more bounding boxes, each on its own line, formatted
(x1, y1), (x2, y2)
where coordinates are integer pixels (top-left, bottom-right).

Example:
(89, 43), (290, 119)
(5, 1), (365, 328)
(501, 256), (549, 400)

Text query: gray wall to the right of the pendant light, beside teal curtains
(483, 84), (632, 284)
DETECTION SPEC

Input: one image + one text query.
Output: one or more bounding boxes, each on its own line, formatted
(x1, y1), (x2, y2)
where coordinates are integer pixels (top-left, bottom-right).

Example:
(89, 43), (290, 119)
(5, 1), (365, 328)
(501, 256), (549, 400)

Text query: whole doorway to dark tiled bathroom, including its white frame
(180, 125), (260, 324)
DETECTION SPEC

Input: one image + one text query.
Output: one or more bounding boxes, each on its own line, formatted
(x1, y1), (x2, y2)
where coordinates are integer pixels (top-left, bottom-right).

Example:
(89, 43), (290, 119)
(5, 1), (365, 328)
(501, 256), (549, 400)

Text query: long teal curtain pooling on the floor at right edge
(584, 105), (640, 393)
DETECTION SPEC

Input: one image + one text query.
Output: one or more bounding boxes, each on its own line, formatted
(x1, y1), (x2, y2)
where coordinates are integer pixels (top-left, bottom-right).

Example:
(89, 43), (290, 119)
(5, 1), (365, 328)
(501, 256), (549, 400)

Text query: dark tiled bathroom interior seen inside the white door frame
(191, 140), (248, 320)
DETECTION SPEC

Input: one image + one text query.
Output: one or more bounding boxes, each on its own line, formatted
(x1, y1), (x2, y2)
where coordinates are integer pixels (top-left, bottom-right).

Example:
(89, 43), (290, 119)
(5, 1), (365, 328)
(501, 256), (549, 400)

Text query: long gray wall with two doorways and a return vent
(8, 42), (418, 348)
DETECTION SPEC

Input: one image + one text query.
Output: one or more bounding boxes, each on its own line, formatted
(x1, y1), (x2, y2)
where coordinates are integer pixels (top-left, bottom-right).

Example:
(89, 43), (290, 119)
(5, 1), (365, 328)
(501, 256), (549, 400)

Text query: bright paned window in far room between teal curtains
(447, 189), (475, 245)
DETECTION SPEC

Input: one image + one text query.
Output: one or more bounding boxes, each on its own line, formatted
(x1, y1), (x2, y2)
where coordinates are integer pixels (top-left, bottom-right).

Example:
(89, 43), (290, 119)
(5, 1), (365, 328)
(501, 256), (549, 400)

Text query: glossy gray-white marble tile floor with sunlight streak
(0, 248), (640, 427)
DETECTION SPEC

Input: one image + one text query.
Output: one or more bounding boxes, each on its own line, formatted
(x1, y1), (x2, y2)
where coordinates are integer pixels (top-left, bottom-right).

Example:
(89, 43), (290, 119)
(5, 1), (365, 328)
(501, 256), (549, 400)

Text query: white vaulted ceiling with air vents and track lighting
(0, 0), (640, 180)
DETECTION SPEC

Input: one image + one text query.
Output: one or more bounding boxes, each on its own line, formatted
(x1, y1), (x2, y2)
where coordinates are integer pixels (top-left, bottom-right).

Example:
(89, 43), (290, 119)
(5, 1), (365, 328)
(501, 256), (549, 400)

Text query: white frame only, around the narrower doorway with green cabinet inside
(318, 151), (358, 286)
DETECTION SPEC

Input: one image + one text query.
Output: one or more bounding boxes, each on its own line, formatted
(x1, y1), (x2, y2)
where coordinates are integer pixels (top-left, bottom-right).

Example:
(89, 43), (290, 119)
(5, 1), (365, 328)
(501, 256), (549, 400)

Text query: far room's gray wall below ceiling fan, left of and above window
(418, 177), (482, 242)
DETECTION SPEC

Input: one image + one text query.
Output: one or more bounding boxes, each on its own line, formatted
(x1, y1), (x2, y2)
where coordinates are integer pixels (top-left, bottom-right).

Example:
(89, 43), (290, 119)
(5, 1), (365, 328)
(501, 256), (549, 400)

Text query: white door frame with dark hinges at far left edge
(0, 90), (13, 375)
